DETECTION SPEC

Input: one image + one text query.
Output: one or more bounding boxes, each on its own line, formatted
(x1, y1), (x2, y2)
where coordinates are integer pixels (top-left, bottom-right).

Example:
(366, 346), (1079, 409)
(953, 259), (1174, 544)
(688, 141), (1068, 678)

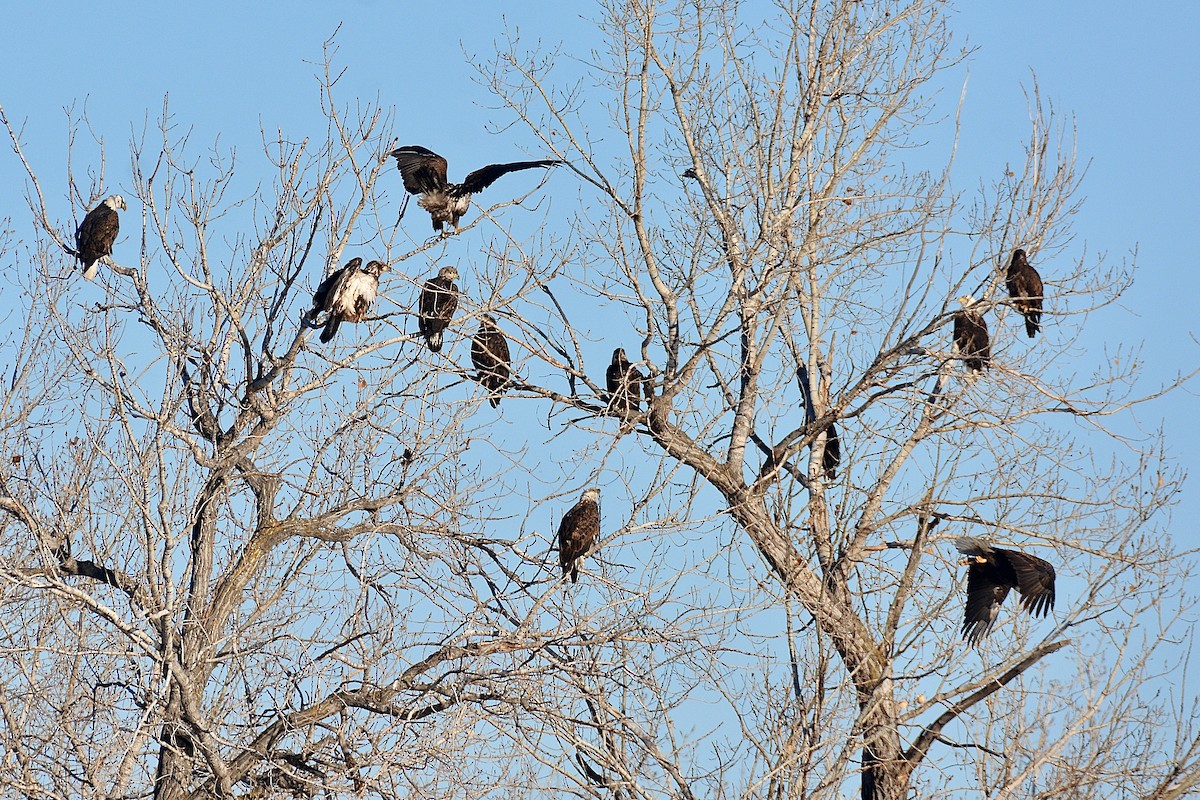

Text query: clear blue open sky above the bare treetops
(0, 0), (1200, 614)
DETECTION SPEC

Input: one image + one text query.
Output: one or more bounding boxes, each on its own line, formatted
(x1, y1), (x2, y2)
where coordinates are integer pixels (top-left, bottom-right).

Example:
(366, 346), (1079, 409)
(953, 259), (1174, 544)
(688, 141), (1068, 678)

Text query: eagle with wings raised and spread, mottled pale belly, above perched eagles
(388, 144), (563, 231)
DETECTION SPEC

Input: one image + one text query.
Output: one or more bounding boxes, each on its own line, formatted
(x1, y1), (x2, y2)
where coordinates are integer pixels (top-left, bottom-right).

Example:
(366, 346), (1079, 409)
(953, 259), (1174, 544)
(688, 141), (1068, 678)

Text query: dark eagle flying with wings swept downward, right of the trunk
(954, 536), (1055, 645)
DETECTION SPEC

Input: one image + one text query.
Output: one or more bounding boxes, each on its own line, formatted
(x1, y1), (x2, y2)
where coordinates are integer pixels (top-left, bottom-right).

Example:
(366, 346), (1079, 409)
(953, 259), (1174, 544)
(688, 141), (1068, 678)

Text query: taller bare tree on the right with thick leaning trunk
(463, 0), (1200, 799)
